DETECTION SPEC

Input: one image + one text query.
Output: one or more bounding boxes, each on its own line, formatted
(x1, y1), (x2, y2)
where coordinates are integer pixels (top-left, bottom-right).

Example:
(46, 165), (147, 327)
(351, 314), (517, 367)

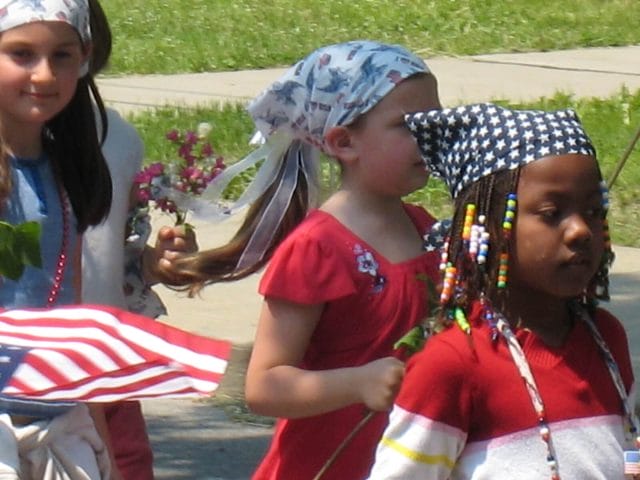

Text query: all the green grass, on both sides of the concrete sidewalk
(110, 0), (640, 246)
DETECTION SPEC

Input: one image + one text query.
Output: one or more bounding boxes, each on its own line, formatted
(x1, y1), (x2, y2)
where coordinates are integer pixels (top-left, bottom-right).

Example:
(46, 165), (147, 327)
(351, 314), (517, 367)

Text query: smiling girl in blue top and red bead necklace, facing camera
(0, 0), (117, 479)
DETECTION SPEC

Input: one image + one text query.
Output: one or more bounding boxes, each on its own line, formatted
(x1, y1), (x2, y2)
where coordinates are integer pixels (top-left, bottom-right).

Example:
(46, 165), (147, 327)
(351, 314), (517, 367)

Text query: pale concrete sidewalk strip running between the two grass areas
(98, 45), (640, 112)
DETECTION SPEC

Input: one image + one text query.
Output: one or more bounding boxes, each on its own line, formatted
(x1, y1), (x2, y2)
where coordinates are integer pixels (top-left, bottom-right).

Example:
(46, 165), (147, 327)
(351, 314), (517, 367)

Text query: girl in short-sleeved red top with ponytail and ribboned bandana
(178, 41), (440, 480)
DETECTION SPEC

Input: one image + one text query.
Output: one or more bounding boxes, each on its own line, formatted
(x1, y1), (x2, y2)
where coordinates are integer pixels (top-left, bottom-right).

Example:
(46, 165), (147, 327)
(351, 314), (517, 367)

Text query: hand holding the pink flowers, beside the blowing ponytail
(144, 225), (198, 285)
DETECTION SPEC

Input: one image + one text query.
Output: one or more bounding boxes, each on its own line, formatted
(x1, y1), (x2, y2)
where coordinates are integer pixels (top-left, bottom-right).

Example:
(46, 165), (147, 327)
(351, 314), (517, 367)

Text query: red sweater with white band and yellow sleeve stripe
(370, 310), (633, 480)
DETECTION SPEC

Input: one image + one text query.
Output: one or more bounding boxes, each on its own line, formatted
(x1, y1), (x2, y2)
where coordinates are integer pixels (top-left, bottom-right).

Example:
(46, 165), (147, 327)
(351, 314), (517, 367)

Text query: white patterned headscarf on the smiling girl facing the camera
(0, 0), (91, 44)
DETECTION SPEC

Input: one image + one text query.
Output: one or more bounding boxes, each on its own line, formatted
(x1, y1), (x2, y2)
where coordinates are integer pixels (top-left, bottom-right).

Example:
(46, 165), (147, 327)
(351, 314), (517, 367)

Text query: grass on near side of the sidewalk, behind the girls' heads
(130, 90), (640, 247)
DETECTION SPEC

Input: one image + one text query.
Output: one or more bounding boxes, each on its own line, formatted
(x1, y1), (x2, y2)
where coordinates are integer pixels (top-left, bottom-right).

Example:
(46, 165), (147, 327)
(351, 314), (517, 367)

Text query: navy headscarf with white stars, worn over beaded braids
(405, 103), (596, 198)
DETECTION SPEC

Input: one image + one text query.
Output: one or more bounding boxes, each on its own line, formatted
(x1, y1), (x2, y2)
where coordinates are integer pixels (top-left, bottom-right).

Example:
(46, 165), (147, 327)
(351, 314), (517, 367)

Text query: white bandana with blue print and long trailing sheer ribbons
(188, 40), (429, 270)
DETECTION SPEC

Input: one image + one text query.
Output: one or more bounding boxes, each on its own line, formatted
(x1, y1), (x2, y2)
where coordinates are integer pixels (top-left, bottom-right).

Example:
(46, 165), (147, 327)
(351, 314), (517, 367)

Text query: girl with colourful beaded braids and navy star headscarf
(370, 104), (639, 480)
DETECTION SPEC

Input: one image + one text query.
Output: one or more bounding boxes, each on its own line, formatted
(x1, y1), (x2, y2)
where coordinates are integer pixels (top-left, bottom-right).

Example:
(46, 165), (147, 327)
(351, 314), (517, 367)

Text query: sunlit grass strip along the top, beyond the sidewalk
(102, 0), (640, 74)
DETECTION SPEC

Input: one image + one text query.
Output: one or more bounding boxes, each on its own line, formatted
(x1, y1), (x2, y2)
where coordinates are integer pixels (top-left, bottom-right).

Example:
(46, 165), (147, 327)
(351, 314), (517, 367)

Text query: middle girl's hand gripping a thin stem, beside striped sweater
(357, 357), (404, 411)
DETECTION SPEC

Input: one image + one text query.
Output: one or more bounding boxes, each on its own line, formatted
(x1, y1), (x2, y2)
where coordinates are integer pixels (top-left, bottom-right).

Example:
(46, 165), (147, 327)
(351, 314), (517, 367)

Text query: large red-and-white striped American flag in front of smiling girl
(0, 305), (231, 402)
